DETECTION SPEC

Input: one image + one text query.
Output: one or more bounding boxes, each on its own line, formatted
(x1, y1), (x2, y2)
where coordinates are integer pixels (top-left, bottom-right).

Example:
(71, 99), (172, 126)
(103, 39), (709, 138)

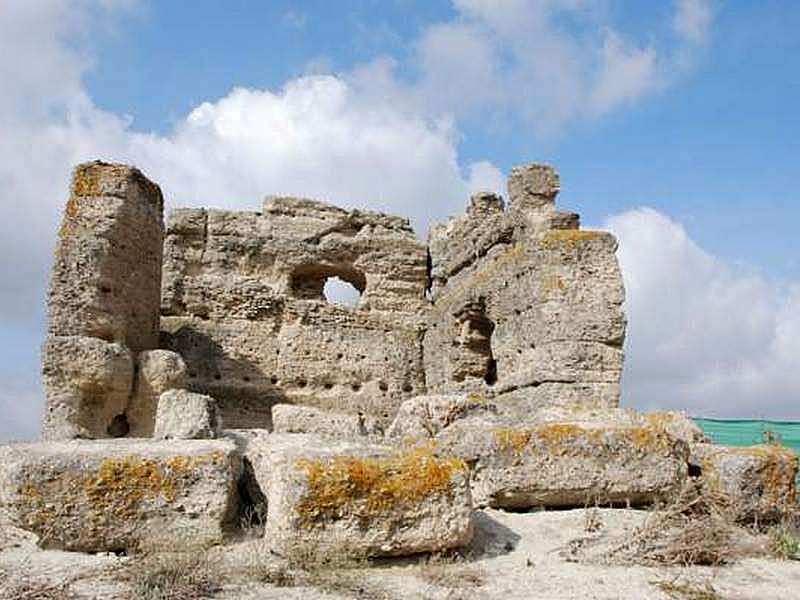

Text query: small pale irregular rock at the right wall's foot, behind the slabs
(386, 392), (497, 440)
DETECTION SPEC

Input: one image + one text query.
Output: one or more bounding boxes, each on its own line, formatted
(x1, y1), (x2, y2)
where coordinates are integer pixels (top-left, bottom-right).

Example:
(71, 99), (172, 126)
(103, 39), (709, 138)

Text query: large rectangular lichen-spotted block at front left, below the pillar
(0, 439), (241, 552)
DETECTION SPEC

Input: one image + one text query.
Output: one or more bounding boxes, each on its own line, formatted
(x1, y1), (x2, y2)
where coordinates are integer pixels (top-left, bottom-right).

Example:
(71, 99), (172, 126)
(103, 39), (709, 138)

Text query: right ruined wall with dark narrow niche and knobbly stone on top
(424, 165), (625, 405)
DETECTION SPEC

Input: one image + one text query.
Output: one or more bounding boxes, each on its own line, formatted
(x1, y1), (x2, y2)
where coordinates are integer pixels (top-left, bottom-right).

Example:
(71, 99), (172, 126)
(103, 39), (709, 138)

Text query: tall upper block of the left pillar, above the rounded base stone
(47, 162), (164, 354)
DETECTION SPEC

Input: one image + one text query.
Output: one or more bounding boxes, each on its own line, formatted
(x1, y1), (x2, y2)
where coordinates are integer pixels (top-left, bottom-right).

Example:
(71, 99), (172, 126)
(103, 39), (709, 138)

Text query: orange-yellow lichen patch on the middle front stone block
(295, 446), (466, 526)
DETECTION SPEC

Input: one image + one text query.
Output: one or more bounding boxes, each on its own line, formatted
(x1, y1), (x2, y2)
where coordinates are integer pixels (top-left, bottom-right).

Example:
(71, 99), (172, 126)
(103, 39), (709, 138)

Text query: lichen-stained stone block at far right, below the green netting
(689, 444), (798, 521)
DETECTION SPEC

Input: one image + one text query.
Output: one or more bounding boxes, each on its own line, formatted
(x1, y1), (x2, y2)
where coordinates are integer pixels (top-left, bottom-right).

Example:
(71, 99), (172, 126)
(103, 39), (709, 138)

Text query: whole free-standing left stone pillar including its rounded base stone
(42, 161), (164, 439)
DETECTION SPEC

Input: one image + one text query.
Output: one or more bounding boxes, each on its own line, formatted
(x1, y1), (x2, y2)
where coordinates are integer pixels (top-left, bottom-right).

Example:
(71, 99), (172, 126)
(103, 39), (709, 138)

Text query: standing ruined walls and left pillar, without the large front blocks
(43, 162), (625, 439)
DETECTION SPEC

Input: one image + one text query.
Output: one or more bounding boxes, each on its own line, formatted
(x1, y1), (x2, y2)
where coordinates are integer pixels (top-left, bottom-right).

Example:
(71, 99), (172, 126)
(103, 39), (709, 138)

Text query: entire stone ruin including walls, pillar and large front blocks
(0, 162), (797, 555)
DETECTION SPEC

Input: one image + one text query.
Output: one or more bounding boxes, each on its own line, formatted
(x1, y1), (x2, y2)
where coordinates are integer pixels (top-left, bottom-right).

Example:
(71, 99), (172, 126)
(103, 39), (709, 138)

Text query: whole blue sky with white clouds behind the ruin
(0, 0), (800, 437)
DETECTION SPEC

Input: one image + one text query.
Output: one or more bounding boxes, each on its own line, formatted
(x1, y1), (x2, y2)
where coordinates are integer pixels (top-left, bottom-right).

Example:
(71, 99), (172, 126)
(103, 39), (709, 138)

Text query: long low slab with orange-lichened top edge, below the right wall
(436, 417), (689, 509)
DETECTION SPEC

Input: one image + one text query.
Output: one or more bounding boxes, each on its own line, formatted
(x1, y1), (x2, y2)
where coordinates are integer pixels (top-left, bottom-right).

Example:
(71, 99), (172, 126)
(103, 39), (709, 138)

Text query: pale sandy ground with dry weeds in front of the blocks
(0, 509), (800, 600)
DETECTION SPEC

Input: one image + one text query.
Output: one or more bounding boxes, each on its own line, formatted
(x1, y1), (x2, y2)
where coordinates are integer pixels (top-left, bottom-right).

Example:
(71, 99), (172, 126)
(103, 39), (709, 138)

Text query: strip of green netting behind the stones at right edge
(694, 418), (800, 486)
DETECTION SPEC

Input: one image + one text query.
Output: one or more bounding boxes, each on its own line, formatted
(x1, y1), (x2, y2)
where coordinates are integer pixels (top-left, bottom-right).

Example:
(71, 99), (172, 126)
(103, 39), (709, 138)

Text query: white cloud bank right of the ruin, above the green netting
(606, 208), (800, 418)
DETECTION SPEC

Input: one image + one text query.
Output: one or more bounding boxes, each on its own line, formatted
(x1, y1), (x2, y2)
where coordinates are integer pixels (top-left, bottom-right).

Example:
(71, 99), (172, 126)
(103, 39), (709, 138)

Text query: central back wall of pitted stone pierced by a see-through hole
(162, 198), (427, 427)
